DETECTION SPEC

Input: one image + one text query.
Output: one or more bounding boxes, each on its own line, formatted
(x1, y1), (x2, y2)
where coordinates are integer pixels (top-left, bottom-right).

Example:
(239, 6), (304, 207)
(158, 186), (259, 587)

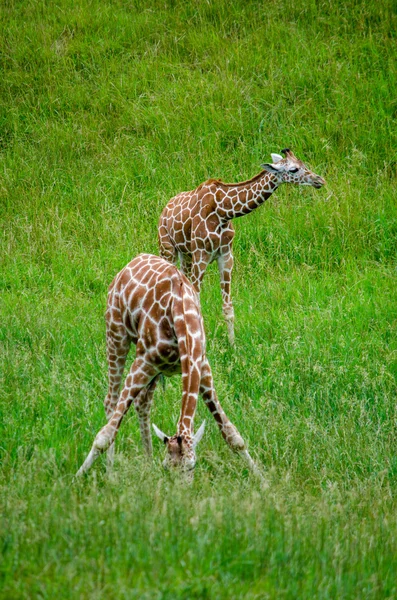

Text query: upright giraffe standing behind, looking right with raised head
(158, 148), (325, 345)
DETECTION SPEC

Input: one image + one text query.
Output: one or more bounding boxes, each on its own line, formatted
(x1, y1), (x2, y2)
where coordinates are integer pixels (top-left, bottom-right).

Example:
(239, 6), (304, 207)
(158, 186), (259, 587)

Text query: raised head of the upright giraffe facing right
(261, 148), (325, 189)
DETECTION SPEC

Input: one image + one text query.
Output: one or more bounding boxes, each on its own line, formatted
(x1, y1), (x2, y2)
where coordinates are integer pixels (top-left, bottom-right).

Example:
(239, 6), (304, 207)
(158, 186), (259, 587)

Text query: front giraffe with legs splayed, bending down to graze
(77, 254), (258, 475)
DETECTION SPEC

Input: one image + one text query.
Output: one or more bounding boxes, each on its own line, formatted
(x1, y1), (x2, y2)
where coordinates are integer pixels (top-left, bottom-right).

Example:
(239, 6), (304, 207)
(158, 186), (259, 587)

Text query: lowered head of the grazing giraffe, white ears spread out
(153, 421), (205, 471)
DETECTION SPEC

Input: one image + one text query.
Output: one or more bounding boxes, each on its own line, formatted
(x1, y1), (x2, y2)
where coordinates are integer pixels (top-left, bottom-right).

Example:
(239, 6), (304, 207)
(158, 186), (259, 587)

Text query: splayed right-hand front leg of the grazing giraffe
(200, 359), (259, 474)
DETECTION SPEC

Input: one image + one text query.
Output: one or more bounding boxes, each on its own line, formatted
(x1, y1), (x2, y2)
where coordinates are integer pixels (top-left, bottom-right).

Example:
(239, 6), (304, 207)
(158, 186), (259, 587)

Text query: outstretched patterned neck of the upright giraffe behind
(213, 172), (279, 221)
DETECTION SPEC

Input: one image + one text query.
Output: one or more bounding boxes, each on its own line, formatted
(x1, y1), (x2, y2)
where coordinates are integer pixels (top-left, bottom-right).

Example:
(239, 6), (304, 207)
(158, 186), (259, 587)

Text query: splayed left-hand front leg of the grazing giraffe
(77, 356), (157, 476)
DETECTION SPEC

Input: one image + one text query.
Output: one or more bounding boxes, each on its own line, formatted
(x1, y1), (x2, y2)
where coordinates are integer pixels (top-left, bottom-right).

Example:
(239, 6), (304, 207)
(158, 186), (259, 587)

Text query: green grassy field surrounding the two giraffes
(0, 0), (397, 600)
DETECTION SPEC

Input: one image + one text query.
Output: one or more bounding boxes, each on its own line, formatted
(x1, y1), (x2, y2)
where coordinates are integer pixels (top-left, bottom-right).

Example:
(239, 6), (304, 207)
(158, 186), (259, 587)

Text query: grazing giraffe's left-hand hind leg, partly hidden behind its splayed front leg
(104, 325), (131, 471)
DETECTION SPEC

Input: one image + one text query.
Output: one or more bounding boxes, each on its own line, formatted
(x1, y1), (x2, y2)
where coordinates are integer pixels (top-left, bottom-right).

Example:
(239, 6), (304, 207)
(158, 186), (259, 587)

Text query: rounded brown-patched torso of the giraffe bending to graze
(106, 254), (205, 375)
